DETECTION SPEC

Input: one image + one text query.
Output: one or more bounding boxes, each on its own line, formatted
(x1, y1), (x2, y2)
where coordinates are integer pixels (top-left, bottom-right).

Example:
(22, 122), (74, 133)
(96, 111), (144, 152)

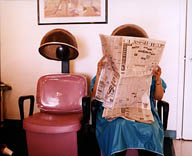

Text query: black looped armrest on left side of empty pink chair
(19, 95), (35, 120)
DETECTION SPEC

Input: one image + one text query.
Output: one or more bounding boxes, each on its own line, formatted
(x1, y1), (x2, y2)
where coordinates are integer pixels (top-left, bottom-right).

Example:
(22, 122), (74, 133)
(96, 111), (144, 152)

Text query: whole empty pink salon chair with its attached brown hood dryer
(19, 29), (90, 156)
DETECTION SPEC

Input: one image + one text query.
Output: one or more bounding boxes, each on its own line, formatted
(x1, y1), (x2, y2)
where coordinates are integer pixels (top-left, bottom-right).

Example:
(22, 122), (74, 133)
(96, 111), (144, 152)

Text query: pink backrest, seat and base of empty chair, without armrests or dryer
(20, 74), (87, 156)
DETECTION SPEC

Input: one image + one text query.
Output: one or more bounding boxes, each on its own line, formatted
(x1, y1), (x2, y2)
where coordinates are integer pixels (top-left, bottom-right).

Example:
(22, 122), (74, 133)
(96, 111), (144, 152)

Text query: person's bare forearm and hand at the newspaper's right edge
(153, 66), (164, 100)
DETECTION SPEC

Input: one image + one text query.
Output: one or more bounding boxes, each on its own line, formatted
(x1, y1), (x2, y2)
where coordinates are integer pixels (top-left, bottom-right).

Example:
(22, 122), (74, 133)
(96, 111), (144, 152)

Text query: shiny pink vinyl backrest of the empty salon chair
(36, 74), (87, 113)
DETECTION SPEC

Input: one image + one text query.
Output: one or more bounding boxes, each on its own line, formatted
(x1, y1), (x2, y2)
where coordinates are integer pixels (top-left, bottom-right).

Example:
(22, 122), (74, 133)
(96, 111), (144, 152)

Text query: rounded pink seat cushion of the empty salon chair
(23, 112), (82, 133)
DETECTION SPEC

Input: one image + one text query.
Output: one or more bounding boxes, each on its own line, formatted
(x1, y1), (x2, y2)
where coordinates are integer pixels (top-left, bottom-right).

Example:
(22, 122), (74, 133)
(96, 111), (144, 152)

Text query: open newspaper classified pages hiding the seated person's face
(94, 35), (165, 123)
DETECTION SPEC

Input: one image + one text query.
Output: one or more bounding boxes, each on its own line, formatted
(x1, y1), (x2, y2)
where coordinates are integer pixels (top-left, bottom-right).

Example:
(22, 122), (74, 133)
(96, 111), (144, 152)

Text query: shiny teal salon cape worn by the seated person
(91, 77), (166, 156)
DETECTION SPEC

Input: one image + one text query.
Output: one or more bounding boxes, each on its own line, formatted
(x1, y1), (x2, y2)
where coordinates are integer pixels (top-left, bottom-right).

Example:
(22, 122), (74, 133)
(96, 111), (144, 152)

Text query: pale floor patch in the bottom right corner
(173, 140), (192, 156)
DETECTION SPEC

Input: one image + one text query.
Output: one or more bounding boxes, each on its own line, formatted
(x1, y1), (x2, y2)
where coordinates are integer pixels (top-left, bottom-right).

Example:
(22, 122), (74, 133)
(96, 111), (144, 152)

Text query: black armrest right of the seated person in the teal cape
(157, 100), (169, 131)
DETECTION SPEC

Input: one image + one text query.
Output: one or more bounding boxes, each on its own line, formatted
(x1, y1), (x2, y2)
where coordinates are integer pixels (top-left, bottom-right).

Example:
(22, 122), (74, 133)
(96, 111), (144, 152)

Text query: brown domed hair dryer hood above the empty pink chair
(39, 29), (79, 61)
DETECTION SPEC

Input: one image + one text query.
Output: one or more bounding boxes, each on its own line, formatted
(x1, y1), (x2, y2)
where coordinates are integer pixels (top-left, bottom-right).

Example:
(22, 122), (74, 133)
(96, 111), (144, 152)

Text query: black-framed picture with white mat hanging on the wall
(37, 0), (108, 25)
